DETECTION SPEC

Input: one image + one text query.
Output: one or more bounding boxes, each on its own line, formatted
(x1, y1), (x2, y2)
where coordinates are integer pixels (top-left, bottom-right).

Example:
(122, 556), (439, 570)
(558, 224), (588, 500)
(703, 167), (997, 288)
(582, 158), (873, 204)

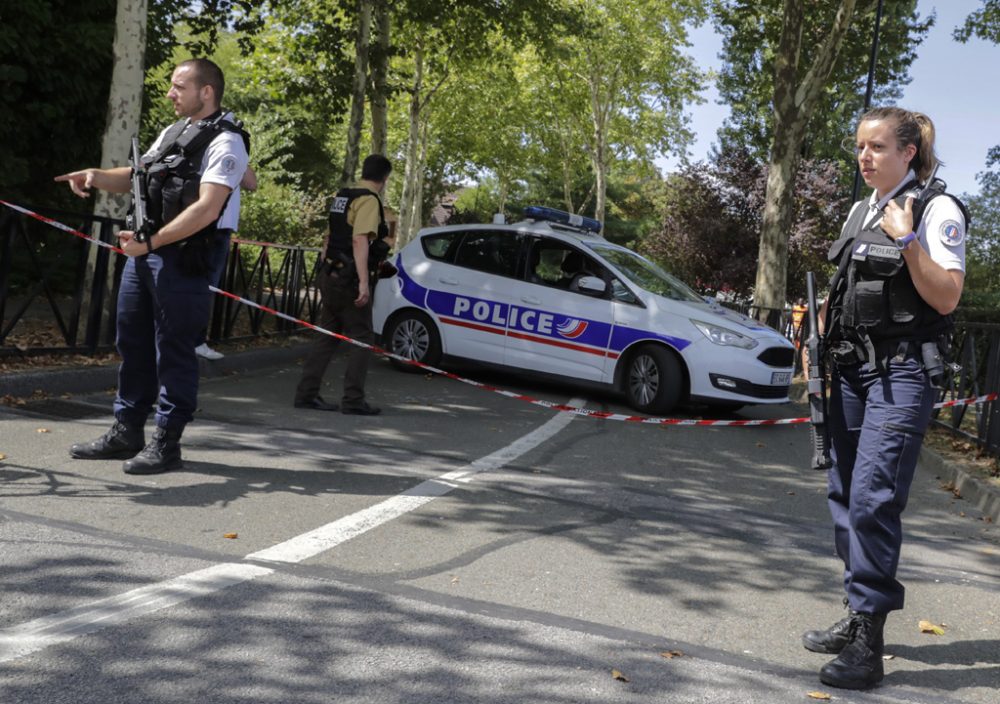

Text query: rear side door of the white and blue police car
(427, 229), (522, 364)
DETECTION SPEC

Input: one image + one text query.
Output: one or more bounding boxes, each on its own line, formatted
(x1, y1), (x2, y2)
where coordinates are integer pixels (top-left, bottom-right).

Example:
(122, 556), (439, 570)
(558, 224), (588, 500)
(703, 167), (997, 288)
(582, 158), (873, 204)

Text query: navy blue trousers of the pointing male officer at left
(114, 246), (211, 428)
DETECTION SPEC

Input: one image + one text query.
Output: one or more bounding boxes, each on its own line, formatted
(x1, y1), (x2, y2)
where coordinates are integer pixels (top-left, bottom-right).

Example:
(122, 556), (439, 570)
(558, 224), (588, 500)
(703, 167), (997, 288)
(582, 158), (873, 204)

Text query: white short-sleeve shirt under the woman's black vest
(848, 170), (966, 272)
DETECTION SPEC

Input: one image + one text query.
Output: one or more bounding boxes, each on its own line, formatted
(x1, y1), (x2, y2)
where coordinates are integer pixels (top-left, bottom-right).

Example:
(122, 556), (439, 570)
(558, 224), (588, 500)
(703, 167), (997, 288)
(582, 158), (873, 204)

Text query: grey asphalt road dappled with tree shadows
(0, 352), (1000, 704)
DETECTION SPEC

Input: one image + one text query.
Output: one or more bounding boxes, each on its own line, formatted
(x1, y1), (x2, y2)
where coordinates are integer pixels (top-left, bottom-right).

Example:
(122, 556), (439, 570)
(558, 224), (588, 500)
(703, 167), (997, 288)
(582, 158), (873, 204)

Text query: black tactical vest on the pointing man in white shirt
(143, 111), (250, 231)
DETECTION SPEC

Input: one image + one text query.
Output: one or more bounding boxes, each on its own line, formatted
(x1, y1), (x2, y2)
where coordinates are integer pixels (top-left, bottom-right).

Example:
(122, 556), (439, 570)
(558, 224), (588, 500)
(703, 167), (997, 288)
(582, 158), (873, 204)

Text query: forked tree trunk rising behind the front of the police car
(754, 0), (877, 320)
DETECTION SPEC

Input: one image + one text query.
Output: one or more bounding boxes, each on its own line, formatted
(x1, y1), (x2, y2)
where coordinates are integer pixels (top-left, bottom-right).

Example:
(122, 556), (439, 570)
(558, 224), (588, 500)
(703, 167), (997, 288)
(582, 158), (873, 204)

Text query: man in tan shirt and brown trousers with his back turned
(295, 154), (392, 416)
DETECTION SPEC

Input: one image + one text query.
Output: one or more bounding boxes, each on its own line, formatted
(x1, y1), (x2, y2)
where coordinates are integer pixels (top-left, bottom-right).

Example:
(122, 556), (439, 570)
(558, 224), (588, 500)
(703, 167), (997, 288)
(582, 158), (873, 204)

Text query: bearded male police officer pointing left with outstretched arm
(56, 59), (249, 474)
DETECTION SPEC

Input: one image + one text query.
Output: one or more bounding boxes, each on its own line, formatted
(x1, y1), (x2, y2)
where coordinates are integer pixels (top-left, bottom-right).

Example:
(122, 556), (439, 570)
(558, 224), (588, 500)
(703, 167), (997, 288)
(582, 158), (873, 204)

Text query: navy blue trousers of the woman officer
(827, 357), (935, 613)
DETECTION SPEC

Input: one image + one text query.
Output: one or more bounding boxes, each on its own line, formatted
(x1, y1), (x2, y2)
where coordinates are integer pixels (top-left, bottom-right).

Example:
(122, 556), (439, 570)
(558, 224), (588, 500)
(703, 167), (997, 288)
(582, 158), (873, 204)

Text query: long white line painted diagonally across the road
(0, 399), (580, 662)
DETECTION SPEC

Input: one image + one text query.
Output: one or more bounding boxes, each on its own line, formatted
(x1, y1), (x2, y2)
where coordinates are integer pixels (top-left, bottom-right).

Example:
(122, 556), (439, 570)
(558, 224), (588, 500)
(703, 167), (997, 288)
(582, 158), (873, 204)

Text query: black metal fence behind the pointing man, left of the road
(0, 208), (320, 357)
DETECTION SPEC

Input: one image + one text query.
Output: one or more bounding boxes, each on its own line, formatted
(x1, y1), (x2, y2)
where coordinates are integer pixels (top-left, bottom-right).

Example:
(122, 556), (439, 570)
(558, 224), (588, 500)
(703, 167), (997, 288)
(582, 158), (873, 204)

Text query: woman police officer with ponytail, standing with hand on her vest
(803, 107), (968, 689)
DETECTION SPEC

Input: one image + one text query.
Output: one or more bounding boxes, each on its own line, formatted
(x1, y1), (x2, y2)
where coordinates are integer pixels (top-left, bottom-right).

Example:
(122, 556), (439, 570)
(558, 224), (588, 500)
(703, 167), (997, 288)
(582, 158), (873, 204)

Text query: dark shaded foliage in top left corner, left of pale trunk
(0, 0), (115, 210)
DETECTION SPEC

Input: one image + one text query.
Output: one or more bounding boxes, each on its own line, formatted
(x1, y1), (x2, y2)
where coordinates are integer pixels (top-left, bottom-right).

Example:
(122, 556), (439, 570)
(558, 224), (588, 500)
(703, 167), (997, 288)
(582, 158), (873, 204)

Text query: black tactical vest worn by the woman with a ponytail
(827, 180), (969, 345)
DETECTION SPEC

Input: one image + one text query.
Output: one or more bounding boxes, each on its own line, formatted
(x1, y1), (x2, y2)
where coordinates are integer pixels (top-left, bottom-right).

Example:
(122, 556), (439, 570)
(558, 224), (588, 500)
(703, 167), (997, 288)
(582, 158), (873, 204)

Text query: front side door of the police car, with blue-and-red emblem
(505, 237), (614, 381)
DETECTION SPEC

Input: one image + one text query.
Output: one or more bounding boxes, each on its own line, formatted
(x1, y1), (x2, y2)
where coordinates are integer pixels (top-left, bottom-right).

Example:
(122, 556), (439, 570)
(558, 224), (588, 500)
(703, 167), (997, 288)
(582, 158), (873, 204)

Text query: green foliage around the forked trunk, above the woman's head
(714, 0), (934, 188)
